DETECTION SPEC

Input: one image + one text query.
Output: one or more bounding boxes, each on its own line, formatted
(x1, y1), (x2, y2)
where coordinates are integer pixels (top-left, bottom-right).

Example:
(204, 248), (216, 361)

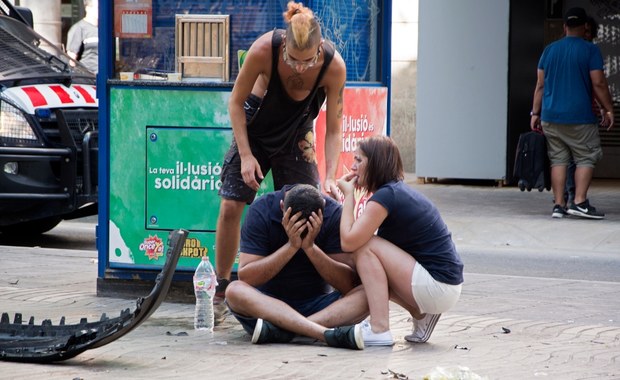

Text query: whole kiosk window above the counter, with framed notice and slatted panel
(113, 0), (380, 82)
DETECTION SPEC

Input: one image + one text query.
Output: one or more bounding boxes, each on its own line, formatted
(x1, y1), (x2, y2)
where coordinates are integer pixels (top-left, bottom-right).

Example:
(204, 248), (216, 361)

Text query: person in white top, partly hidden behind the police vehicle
(67, 0), (99, 74)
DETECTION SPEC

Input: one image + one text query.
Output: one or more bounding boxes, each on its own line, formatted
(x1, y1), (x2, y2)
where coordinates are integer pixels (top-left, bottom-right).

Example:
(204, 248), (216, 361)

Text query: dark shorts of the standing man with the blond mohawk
(218, 98), (321, 204)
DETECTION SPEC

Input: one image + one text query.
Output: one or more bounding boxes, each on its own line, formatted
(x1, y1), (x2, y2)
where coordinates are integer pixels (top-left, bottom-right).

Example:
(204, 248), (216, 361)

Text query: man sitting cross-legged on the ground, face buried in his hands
(226, 185), (368, 350)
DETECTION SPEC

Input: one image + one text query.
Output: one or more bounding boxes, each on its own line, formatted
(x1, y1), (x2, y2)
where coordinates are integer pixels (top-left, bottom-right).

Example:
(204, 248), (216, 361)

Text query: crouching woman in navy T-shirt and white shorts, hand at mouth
(338, 136), (463, 346)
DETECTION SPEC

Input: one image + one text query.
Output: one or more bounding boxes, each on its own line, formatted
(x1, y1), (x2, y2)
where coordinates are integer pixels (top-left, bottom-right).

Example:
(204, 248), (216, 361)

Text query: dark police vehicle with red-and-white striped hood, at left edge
(0, 0), (98, 236)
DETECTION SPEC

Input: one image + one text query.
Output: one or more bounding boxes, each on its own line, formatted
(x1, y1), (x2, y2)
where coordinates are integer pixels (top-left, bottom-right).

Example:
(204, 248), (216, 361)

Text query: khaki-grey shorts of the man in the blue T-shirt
(541, 121), (603, 168)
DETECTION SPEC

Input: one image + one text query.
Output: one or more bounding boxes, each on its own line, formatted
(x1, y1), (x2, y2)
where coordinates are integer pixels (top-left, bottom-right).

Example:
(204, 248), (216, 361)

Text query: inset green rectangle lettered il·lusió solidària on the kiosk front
(144, 127), (232, 232)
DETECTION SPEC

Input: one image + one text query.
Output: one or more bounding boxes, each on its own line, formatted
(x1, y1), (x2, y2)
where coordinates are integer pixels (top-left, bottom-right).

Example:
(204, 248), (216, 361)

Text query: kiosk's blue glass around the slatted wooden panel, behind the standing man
(114, 0), (383, 81)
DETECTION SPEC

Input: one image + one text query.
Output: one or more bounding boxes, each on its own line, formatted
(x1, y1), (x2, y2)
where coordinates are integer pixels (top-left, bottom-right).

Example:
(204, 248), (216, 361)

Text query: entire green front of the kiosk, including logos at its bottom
(108, 87), (273, 270)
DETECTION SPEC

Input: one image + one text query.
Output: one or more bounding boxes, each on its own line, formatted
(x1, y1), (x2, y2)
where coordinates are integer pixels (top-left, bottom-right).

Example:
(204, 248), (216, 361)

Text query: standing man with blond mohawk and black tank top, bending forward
(214, 1), (346, 321)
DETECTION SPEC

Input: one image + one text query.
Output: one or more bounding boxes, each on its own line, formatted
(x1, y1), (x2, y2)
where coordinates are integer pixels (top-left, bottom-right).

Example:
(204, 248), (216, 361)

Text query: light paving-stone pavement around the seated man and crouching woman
(0, 178), (620, 380)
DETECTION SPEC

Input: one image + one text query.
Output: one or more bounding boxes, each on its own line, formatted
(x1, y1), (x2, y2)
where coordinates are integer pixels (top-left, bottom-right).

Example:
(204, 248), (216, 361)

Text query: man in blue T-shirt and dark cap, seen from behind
(530, 8), (614, 219)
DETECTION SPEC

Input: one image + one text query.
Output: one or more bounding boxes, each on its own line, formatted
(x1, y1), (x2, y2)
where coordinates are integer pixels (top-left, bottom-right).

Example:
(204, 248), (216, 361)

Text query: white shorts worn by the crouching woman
(411, 262), (463, 314)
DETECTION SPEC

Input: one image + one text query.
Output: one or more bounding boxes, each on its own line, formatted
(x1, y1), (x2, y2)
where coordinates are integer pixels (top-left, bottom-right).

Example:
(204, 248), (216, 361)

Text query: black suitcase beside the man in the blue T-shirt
(513, 131), (551, 191)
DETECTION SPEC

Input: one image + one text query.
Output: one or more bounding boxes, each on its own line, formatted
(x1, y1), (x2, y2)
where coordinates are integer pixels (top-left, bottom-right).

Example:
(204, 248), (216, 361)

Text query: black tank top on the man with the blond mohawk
(247, 29), (334, 156)
